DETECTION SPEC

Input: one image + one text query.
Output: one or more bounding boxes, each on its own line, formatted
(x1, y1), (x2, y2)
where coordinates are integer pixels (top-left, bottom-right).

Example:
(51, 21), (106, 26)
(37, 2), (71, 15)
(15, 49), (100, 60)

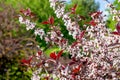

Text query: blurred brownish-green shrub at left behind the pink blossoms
(0, 3), (39, 80)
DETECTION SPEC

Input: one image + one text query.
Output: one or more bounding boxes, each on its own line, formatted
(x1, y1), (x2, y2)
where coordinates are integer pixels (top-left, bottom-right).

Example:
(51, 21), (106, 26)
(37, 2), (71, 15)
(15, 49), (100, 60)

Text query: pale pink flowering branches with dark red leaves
(19, 0), (120, 80)
